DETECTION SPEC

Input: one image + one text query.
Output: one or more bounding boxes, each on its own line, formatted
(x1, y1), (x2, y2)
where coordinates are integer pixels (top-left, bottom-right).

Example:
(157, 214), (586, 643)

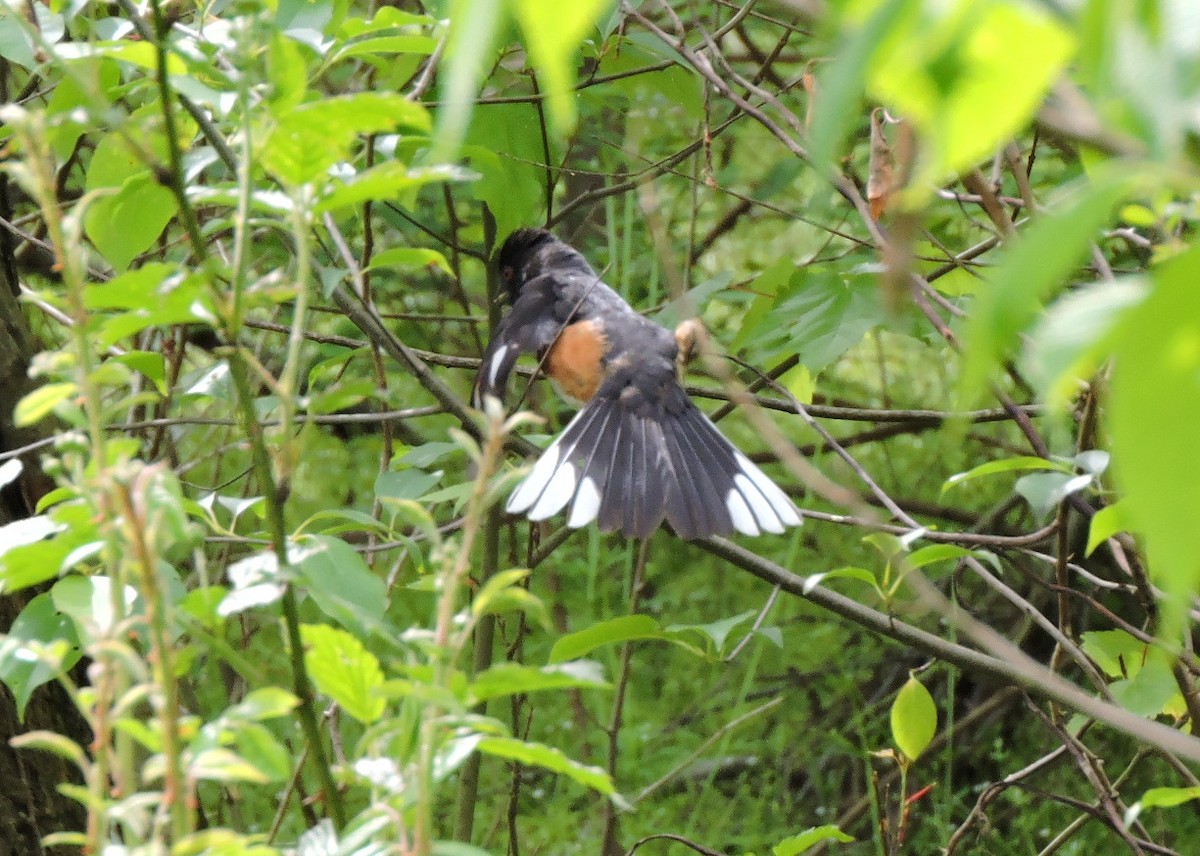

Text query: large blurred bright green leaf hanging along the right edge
(1108, 247), (1200, 619)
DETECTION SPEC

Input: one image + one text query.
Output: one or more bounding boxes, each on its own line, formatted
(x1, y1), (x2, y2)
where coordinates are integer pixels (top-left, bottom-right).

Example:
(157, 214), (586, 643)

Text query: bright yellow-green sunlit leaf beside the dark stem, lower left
(300, 624), (386, 725)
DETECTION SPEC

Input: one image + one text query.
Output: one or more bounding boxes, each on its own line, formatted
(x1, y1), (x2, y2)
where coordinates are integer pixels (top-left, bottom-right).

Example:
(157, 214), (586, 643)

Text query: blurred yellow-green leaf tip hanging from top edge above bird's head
(516, 0), (613, 137)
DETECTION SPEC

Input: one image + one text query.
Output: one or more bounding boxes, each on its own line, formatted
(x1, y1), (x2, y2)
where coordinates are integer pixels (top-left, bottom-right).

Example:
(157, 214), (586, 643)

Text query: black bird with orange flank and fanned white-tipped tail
(473, 228), (802, 540)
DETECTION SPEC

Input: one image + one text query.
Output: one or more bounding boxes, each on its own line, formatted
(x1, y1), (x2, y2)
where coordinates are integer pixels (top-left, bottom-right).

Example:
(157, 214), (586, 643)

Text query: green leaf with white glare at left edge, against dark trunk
(0, 593), (79, 719)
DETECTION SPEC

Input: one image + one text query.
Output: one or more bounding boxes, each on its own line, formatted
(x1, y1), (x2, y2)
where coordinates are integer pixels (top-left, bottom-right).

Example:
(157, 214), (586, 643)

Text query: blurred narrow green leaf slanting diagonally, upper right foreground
(958, 179), (1126, 408)
